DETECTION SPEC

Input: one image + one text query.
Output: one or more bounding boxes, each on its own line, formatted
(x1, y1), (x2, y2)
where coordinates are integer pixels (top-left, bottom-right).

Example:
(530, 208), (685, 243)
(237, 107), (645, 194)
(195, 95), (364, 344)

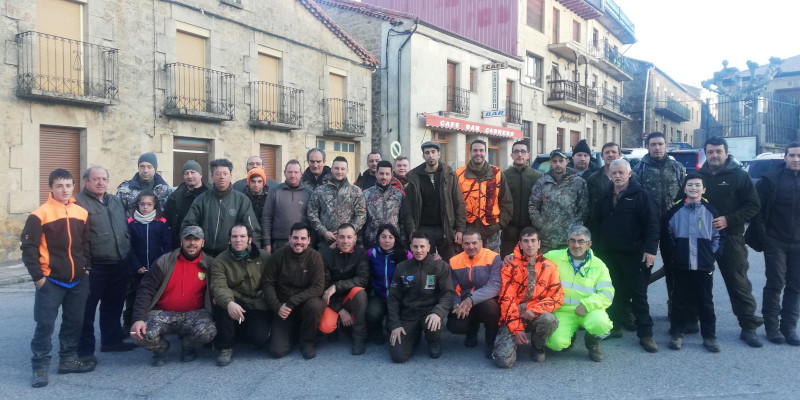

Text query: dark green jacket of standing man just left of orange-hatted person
(181, 189), (261, 257)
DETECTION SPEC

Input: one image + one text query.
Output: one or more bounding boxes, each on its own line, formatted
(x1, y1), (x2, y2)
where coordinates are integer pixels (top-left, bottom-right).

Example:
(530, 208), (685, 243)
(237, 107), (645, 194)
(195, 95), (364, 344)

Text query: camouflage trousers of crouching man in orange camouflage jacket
(492, 313), (558, 368)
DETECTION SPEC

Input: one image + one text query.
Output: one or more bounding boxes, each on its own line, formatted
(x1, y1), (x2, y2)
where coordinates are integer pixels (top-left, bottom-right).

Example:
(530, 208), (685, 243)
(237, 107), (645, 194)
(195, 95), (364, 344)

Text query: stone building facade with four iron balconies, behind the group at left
(0, 0), (378, 262)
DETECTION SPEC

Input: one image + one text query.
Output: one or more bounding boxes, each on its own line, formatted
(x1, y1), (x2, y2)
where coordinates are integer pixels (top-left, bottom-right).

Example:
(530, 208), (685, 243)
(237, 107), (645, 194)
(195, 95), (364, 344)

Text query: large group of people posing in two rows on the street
(21, 132), (800, 387)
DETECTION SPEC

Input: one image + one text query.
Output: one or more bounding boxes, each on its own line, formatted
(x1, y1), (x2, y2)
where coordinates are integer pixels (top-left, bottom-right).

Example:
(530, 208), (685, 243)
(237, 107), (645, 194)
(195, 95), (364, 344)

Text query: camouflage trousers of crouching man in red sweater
(133, 308), (217, 353)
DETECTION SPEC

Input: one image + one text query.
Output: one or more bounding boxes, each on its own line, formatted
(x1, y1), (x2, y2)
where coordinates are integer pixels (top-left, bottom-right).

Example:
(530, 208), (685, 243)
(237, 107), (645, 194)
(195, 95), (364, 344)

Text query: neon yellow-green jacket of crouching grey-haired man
(544, 249), (614, 312)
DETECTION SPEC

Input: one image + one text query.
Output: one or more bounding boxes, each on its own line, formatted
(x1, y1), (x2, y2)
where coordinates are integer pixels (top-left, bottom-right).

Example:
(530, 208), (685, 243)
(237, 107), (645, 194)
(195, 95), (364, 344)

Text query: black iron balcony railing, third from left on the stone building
(250, 82), (303, 129)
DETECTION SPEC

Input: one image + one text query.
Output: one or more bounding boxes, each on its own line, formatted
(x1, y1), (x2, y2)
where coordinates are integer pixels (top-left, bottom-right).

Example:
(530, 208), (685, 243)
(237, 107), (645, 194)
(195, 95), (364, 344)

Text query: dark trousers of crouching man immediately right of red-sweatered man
(214, 305), (270, 349)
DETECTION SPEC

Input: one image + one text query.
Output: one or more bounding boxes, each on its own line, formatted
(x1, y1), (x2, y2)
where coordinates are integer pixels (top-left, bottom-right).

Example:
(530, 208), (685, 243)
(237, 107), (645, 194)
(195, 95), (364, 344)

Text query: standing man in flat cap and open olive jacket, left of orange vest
(403, 141), (467, 261)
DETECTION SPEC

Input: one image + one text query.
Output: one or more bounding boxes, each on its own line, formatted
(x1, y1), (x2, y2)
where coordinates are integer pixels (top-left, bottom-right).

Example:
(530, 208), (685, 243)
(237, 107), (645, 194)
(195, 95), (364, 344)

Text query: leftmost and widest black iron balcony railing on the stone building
(16, 32), (119, 105)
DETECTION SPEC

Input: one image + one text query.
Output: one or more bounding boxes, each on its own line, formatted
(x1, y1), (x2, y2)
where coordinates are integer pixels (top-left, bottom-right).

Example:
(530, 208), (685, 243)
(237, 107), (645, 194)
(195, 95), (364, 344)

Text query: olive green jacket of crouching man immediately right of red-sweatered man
(208, 243), (270, 311)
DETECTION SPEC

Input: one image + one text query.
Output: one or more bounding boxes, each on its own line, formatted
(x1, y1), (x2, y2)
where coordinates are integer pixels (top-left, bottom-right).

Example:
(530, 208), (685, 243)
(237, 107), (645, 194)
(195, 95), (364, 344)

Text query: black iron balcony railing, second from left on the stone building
(164, 63), (236, 121)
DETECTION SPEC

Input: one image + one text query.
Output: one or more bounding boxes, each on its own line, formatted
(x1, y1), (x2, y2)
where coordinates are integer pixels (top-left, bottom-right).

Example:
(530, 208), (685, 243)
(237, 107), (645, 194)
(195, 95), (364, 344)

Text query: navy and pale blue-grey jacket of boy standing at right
(664, 199), (722, 271)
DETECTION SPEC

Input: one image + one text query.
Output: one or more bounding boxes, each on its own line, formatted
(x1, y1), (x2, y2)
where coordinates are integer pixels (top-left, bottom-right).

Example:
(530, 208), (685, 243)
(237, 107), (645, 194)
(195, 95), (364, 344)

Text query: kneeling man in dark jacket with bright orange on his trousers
(320, 224), (369, 355)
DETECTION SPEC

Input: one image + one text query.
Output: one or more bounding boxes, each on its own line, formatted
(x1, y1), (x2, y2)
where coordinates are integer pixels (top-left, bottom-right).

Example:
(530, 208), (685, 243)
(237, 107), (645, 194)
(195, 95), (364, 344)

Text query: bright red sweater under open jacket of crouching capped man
(155, 253), (208, 312)
